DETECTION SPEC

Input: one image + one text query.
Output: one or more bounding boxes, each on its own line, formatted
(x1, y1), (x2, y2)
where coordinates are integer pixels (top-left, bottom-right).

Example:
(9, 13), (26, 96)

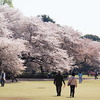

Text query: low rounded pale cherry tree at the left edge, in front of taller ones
(0, 37), (25, 74)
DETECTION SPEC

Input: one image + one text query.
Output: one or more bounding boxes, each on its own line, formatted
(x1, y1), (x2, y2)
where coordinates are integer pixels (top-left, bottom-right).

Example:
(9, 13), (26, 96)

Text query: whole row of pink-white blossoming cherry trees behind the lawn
(0, 6), (100, 74)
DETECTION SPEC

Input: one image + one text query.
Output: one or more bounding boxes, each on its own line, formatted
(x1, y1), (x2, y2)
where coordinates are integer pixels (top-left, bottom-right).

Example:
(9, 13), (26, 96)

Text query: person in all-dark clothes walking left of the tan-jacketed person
(54, 71), (65, 96)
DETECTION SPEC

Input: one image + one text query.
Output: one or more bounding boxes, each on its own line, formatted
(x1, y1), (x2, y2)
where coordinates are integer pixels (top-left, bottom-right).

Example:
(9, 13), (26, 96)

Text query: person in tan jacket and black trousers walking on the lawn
(68, 73), (77, 97)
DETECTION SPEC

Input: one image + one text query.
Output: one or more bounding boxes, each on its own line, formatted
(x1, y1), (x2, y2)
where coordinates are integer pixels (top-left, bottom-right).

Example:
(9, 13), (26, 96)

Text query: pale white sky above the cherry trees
(12, 0), (100, 37)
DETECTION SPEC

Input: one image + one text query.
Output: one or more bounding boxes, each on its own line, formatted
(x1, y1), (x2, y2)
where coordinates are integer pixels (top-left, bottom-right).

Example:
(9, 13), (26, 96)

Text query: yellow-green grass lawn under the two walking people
(0, 80), (100, 100)
